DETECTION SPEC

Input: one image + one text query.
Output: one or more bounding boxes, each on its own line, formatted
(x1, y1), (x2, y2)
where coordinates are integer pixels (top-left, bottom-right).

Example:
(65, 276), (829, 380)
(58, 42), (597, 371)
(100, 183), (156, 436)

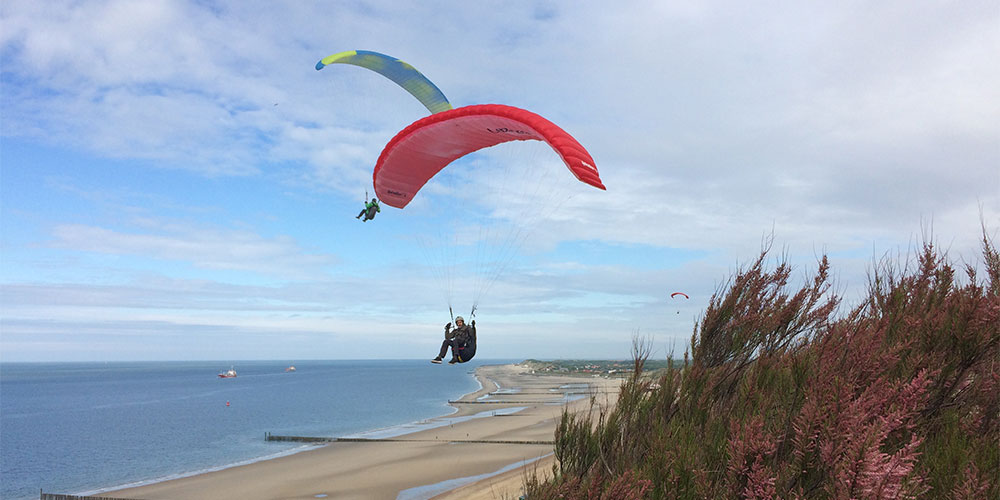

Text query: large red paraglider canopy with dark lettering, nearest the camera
(372, 104), (606, 208)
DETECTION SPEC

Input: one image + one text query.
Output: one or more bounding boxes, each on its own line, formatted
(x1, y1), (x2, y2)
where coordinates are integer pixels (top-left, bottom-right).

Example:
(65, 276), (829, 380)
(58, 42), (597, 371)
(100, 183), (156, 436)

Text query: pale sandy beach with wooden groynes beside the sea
(113, 365), (621, 500)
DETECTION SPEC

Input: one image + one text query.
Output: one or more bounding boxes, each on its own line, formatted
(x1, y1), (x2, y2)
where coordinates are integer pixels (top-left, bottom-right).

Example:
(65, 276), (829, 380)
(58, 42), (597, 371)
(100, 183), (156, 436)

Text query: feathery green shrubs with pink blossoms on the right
(527, 231), (1000, 500)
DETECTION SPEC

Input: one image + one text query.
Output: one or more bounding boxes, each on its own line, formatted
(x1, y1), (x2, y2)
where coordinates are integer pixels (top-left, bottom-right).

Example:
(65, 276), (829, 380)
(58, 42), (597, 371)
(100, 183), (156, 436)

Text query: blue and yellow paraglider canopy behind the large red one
(316, 50), (451, 113)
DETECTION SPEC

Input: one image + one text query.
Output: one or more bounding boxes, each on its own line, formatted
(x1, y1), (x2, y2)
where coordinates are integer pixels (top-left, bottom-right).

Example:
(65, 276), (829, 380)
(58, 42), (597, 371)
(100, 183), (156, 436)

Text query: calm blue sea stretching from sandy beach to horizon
(0, 360), (519, 499)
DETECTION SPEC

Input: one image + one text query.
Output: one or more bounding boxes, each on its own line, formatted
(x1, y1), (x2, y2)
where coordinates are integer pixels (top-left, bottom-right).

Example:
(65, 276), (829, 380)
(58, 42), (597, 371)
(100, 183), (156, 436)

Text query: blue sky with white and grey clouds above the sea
(0, 0), (1000, 363)
